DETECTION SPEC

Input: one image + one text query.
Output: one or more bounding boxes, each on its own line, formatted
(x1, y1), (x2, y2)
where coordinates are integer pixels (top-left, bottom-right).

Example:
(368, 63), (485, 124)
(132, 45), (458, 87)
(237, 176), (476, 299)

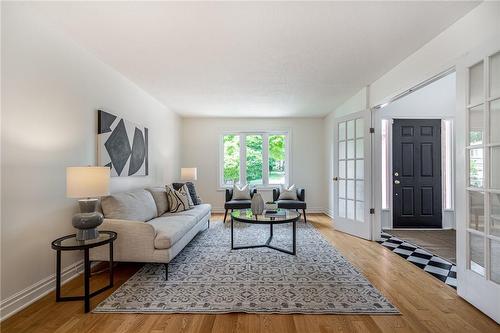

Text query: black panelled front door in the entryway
(392, 119), (442, 228)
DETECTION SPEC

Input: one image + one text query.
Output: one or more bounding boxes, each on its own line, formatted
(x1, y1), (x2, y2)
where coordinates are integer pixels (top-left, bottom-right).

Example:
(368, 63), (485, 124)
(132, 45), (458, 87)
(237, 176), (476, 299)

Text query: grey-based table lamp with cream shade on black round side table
(66, 166), (110, 240)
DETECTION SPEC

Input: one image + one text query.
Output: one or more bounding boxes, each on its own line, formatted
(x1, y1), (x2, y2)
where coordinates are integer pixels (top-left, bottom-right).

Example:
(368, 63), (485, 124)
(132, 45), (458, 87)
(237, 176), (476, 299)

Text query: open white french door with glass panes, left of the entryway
(333, 109), (372, 240)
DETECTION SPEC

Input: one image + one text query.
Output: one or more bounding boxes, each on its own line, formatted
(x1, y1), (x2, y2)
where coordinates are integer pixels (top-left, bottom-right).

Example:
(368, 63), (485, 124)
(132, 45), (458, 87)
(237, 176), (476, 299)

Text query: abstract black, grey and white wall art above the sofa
(97, 110), (149, 177)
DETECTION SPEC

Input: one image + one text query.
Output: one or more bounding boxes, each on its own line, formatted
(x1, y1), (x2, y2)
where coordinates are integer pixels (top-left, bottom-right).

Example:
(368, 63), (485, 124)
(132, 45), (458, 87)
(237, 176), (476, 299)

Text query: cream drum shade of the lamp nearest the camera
(66, 167), (110, 198)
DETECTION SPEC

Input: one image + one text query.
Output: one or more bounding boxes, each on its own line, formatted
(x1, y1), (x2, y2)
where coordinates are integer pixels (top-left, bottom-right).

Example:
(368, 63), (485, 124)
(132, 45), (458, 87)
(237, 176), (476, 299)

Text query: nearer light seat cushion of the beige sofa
(147, 215), (198, 249)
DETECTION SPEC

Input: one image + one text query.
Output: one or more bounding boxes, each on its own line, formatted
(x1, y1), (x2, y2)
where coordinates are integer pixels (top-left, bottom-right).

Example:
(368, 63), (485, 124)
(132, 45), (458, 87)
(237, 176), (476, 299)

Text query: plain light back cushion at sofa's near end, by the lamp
(101, 189), (157, 222)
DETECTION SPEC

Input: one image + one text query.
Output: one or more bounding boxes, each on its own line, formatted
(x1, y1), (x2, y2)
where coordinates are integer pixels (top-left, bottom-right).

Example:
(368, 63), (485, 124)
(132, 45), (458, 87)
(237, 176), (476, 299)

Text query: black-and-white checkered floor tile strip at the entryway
(379, 232), (457, 289)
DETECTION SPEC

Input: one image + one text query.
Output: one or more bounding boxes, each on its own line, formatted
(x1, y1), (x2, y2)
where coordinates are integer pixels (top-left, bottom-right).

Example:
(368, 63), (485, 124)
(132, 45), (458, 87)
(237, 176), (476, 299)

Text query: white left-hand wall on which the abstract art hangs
(1, 3), (180, 317)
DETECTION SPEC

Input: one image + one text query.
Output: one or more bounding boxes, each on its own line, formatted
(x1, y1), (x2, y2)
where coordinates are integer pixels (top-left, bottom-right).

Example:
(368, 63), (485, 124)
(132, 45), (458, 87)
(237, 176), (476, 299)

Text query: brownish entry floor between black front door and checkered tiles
(384, 229), (457, 264)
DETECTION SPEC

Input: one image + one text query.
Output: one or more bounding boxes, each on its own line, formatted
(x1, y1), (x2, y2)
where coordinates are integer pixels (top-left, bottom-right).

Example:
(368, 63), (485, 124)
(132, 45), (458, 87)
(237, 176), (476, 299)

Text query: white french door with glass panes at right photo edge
(457, 38), (500, 322)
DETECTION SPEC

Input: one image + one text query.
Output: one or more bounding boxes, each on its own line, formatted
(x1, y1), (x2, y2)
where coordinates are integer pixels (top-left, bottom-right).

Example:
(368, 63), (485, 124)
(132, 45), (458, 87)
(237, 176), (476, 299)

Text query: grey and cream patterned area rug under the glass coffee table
(94, 222), (399, 314)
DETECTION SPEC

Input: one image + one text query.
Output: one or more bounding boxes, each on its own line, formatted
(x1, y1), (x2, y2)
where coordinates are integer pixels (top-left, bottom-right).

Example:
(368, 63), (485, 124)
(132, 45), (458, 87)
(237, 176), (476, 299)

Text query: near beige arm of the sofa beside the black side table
(90, 219), (156, 262)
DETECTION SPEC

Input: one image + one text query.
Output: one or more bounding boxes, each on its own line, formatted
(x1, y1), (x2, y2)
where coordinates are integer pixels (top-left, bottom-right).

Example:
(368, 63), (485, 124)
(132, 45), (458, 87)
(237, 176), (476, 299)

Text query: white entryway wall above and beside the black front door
(373, 73), (456, 229)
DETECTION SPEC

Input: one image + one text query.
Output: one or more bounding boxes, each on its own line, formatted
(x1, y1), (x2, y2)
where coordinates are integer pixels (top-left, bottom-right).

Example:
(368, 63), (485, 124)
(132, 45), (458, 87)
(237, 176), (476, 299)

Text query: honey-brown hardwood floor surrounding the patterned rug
(1, 214), (500, 333)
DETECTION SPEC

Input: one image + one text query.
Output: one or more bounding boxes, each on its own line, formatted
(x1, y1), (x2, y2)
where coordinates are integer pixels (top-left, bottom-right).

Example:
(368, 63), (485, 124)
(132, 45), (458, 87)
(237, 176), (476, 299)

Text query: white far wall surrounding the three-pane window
(181, 118), (326, 211)
